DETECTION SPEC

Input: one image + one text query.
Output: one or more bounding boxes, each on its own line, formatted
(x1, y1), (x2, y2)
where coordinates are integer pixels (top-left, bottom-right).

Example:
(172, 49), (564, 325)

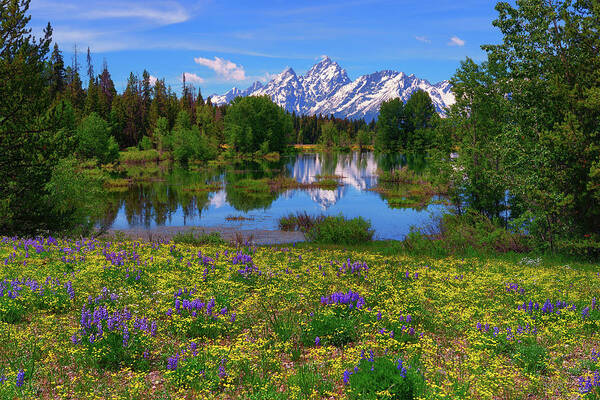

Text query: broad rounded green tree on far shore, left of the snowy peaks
(225, 96), (292, 153)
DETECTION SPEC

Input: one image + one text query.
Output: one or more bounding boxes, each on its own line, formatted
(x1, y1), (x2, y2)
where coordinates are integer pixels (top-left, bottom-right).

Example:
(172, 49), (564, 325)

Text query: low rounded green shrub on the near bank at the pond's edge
(306, 215), (374, 245)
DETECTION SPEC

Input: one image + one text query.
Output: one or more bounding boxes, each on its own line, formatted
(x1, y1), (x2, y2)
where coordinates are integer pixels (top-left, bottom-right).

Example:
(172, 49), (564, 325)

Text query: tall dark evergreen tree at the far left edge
(0, 0), (78, 235)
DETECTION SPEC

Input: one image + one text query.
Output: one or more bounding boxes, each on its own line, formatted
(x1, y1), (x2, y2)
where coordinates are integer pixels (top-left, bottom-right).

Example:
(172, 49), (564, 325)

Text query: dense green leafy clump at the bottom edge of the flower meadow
(347, 357), (426, 400)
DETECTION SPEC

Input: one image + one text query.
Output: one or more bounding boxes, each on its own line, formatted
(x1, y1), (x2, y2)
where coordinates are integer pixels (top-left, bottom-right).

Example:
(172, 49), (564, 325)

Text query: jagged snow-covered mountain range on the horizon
(211, 57), (455, 122)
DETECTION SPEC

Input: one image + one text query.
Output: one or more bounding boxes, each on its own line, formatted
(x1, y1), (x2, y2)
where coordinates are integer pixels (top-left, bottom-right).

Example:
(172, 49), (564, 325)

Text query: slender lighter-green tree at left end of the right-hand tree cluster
(444, 59), (508, 219)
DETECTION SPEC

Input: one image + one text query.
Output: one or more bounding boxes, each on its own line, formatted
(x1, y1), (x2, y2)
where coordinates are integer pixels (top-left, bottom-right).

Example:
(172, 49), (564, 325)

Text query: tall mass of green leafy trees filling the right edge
(440, 0), (600, 250)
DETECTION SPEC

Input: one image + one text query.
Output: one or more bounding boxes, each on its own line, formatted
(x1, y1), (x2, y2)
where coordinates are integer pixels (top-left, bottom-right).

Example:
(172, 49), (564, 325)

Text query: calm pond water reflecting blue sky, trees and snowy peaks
(100, 152), (441, 239)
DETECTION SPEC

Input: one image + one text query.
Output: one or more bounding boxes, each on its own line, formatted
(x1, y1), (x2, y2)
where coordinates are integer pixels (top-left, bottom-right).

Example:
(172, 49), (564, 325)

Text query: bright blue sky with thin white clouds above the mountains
(30, 0), (500, 94)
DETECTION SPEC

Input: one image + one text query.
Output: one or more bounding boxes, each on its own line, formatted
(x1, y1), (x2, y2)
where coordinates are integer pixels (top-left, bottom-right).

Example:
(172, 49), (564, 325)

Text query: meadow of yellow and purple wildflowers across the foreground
(0, 237), (600, 399)
